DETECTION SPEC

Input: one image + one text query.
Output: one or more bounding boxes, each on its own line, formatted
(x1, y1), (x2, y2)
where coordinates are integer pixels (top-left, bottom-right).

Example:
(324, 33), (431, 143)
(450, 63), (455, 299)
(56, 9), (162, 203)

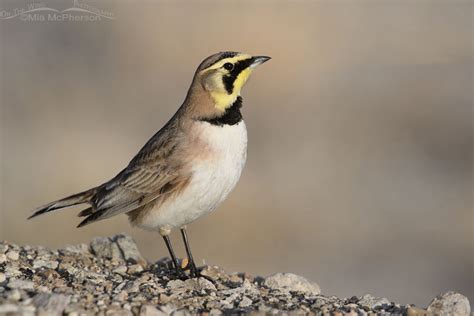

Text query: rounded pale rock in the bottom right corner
(428, 291), (471, 316)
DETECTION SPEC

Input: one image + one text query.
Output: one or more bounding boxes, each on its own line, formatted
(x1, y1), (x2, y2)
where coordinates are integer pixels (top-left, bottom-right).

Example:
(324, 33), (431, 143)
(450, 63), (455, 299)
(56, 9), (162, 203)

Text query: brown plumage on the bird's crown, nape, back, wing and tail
(29, 53), (222, 227)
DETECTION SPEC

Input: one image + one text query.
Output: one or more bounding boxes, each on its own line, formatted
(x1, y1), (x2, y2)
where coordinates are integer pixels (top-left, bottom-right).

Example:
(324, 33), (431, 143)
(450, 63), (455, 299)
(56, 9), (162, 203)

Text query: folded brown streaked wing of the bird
(79, 116), (189, 227)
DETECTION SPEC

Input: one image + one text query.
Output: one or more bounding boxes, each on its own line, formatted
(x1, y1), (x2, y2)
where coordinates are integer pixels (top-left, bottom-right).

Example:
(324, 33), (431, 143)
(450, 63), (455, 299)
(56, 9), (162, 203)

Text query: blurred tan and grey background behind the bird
(0, 0), (474, 306)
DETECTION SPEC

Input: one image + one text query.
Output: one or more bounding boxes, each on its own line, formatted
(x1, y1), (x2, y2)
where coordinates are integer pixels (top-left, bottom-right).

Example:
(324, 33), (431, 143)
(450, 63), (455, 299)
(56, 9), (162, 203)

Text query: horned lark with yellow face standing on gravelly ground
(28, 51), (270, 277)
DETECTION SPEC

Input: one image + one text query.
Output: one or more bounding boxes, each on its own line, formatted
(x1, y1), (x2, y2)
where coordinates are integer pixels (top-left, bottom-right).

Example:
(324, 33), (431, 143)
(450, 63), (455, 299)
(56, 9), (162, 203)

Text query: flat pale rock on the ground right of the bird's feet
(265, 273), (321, 295)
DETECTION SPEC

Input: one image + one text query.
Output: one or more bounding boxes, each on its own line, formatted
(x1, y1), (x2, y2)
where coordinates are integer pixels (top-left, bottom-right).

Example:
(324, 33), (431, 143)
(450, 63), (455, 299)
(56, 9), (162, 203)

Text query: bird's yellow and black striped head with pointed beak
(195, 52), (270, 111)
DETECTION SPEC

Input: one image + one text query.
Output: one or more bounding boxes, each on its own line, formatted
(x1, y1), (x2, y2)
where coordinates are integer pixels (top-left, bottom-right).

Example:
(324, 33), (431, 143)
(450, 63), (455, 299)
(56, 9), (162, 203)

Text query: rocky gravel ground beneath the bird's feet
(0, 235), (470, 316)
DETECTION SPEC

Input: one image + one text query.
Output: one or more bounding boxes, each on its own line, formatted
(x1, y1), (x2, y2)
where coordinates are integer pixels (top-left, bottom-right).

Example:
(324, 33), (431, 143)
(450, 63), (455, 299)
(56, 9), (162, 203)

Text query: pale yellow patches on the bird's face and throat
(202, 54), (252, 111)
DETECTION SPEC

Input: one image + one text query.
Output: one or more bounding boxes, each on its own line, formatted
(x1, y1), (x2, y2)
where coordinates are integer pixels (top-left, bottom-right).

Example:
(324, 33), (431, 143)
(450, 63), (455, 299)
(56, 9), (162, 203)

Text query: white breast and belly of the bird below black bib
(138, 121), (247, 230)
